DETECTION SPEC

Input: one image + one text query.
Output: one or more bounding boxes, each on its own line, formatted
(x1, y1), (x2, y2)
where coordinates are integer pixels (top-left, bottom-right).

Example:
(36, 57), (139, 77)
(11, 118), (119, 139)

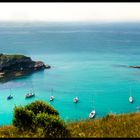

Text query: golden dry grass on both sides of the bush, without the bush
(0, 112), (140, 138)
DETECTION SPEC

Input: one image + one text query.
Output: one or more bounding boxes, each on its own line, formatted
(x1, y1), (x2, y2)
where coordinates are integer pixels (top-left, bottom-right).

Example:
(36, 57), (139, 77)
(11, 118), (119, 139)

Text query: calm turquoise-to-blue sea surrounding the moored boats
(0, 23), (140, 125)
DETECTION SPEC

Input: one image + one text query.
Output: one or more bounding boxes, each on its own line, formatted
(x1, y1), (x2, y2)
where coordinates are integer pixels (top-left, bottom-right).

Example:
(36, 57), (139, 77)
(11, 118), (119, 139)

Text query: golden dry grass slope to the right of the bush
(67, 113), (140, 138)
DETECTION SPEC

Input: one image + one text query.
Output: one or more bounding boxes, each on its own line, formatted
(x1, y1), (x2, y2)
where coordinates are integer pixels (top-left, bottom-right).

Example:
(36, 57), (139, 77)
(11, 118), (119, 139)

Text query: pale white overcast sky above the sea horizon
(0, 2), (140, 22)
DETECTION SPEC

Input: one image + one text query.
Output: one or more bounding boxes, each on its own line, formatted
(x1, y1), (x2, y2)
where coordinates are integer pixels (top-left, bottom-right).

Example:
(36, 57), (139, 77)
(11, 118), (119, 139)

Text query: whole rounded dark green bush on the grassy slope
(13, 101), (70, 137)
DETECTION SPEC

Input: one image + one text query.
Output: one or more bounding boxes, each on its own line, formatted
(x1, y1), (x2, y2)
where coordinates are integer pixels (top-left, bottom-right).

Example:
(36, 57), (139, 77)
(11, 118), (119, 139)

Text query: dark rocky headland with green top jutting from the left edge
(0, 54), (51, 82)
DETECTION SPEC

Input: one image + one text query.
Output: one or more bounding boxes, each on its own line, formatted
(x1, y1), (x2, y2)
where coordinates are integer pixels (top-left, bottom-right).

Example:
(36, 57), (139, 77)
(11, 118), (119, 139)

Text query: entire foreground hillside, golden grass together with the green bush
(0, 101), (140, 138)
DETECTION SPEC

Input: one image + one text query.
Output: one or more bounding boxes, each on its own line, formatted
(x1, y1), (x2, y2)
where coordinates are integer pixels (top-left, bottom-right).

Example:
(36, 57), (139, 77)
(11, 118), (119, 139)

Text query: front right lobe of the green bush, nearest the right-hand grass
(35, 113), (70, 138)
